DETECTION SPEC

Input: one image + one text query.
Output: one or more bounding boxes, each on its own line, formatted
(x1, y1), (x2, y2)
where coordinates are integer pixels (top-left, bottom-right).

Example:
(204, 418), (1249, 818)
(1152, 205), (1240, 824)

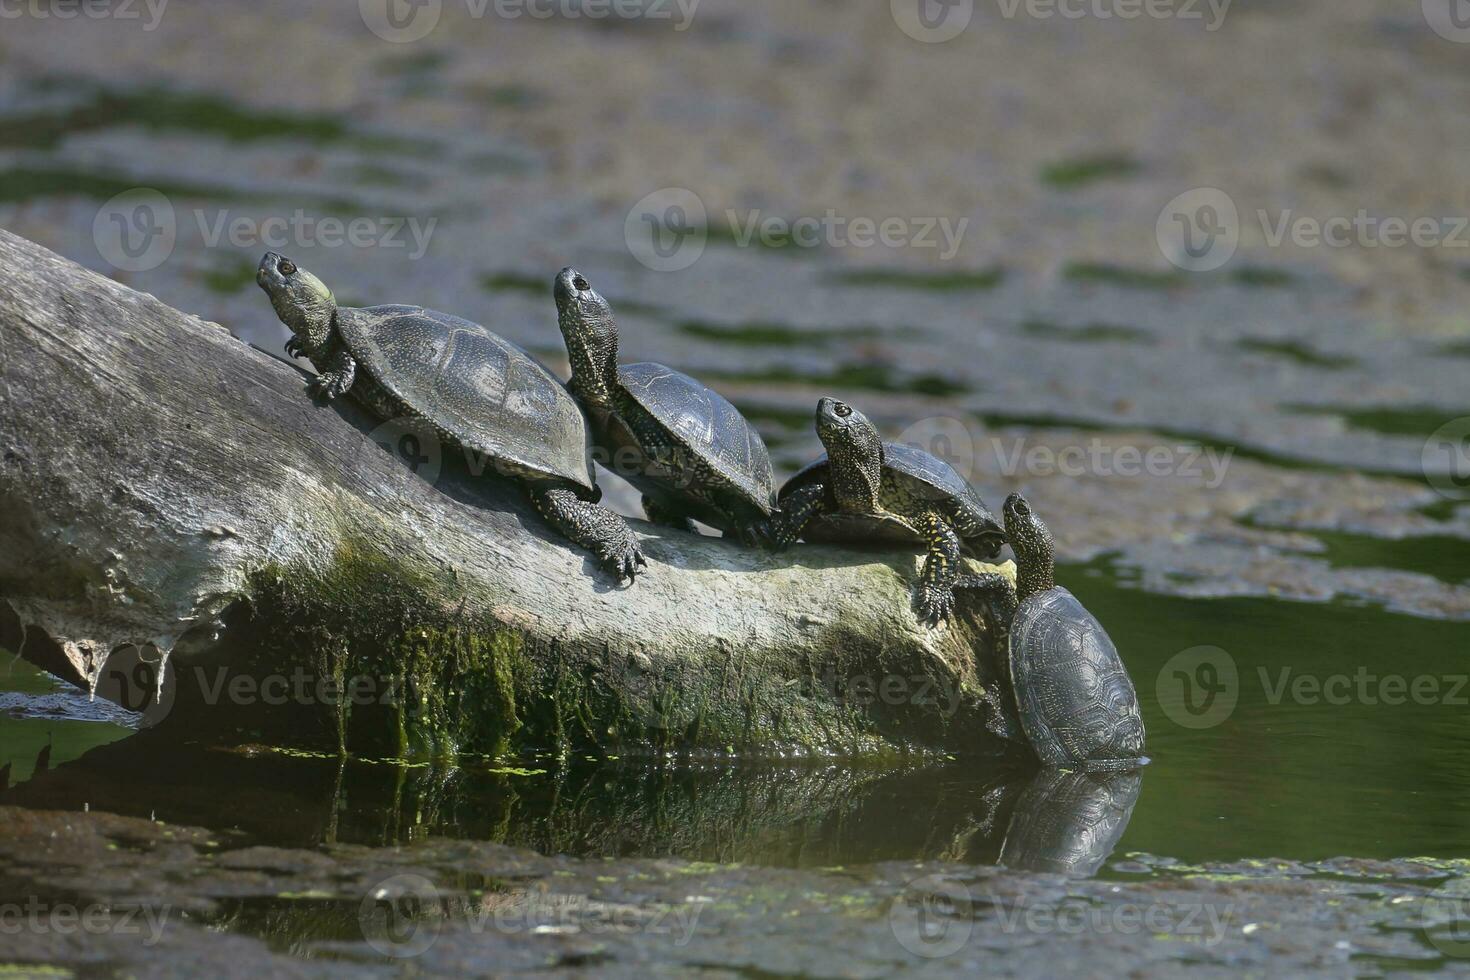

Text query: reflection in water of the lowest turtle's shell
(1000, 770), (1144, 876)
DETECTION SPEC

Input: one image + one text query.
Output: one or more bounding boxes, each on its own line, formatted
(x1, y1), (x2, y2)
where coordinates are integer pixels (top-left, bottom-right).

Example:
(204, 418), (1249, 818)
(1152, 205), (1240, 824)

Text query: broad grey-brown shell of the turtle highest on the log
(337, 306), (595, 489)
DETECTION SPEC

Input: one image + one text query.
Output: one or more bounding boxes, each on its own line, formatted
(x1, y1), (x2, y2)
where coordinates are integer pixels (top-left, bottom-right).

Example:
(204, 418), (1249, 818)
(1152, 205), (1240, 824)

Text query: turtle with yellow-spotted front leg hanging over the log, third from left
(766, 398), (1005, 626)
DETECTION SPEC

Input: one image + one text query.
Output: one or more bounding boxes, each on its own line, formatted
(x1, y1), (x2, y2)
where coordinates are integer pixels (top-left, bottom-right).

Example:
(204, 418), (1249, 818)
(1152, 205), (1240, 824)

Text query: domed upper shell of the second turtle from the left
(617, 363), (776, 514)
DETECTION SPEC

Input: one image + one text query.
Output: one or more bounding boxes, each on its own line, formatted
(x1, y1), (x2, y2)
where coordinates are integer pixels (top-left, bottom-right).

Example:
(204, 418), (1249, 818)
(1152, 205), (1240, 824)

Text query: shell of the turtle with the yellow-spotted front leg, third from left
(781, 442), (1001, 545)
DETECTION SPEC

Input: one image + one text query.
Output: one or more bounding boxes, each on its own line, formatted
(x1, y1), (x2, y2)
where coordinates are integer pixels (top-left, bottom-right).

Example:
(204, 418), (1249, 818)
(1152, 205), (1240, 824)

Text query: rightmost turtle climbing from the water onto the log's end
(956, 494), (1148, 771)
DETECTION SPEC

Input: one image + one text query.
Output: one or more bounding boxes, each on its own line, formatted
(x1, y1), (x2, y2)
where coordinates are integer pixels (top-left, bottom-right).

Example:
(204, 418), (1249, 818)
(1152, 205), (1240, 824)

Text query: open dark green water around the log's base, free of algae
(11, 563), (1470, 867)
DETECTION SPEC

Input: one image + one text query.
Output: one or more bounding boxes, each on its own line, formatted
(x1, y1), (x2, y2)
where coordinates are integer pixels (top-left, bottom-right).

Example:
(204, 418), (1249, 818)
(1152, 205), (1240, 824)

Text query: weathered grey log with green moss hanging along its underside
(0, 232), (1017, 752)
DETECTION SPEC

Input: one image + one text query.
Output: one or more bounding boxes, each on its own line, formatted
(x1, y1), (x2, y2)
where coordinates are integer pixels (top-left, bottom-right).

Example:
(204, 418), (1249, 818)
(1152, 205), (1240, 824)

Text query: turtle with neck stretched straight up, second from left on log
(553, 267), (776, 545)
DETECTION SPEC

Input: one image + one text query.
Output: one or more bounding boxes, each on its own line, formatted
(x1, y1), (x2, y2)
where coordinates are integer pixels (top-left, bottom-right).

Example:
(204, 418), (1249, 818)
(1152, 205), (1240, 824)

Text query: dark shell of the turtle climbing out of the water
(1010, 586), (1144, 768)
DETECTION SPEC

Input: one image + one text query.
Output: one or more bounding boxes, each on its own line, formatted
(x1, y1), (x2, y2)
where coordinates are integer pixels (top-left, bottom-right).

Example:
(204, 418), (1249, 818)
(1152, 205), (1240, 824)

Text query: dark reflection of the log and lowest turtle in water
(0, 732), (1141, 874)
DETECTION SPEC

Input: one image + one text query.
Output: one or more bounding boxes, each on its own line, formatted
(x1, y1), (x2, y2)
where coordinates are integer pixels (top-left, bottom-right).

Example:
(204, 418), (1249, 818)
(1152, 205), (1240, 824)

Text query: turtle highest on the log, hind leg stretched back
(256, 253), (647, 580)
